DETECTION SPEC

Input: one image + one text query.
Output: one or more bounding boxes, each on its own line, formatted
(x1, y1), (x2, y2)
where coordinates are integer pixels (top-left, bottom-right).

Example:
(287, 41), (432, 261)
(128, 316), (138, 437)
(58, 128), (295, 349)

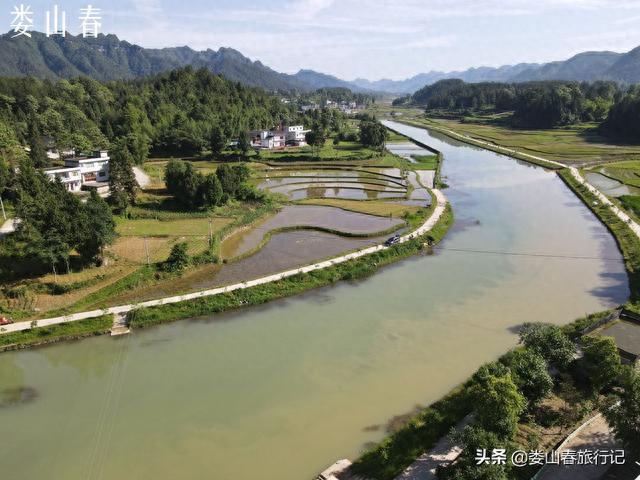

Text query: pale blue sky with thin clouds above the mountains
(7, 0), (640, 80)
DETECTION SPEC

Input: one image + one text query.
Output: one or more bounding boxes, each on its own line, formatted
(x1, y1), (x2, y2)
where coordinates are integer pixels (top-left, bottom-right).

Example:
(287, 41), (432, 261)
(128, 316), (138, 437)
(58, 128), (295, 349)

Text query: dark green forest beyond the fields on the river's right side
(394, 79), (640, 142)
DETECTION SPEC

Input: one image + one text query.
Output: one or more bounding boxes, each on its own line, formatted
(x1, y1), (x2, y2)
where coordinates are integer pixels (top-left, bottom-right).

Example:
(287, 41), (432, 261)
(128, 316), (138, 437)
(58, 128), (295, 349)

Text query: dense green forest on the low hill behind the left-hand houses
(0, 67), (296, 161)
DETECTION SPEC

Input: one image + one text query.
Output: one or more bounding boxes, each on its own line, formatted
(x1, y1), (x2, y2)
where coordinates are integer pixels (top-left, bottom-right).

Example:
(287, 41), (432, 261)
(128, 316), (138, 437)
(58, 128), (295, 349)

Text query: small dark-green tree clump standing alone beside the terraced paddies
(164, 160), (264, 208)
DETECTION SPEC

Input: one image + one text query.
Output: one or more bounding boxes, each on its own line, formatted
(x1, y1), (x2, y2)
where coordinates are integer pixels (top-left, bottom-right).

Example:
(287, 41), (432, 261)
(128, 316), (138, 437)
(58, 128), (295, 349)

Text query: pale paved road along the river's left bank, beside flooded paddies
(0, 189), (447, 335)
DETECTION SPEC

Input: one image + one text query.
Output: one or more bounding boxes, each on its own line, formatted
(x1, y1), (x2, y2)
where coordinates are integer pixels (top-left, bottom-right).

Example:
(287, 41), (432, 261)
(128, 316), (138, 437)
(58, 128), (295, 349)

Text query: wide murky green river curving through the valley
(0, 124), (629, 480)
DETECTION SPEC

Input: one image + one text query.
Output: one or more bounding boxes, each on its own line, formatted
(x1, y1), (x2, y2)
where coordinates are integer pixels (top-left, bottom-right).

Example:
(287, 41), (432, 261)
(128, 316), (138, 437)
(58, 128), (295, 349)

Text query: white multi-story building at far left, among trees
(44, 150), (109, 192)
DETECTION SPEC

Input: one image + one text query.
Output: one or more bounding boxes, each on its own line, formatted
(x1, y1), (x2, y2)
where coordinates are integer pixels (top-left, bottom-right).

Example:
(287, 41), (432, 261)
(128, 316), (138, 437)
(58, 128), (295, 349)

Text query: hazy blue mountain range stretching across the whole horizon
(0, 32), (640, 95)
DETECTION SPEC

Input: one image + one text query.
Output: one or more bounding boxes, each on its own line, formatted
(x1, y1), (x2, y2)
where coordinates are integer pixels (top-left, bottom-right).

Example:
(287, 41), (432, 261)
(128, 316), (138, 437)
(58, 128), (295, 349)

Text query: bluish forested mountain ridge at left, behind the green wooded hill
(0, 32), (312, 91)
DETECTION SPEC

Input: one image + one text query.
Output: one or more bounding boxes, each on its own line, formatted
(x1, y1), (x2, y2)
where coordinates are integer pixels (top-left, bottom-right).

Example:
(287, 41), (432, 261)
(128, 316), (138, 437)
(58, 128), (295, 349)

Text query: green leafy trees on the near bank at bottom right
(438, 324), (640, 480)
